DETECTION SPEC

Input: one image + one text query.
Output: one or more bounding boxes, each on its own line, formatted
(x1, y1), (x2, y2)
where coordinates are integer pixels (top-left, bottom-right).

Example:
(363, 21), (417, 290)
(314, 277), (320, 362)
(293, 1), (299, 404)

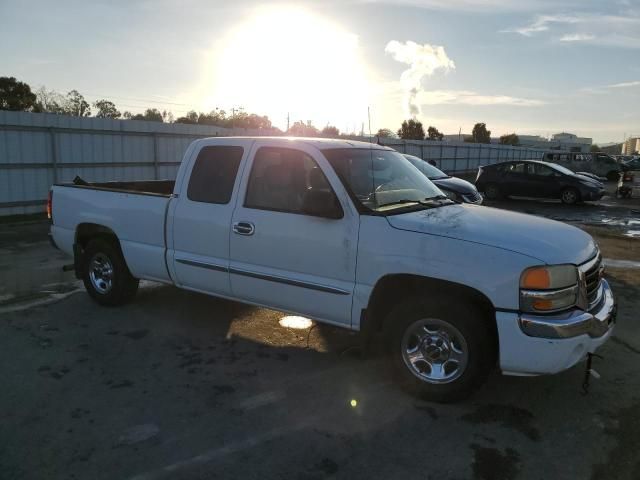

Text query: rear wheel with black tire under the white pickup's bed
(82, 238), (139, 306)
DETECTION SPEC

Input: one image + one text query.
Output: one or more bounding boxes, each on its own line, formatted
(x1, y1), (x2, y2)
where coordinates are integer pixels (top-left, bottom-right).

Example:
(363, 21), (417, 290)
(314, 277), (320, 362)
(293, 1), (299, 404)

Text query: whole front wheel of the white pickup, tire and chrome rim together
(388, 297), (496, 402)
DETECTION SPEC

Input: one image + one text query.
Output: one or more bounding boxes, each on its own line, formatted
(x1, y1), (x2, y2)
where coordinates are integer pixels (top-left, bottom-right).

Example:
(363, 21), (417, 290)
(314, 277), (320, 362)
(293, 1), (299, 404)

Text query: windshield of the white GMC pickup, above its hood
(323, 148), (453, 212)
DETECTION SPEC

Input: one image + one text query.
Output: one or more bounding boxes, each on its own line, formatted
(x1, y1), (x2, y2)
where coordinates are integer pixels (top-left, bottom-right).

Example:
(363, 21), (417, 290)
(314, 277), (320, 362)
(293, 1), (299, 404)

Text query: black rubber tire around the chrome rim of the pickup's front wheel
(386, 297), (497, 403)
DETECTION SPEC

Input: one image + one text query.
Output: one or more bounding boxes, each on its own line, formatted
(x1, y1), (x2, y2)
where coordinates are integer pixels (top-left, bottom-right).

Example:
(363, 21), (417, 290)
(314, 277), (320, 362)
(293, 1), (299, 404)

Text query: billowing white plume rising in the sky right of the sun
(384, 40), (456, 116)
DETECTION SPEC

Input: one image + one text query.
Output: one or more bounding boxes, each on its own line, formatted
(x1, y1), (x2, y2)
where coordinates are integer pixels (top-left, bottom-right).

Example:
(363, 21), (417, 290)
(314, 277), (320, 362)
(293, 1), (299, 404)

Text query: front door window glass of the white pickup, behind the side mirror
(244, 147), (338, 213)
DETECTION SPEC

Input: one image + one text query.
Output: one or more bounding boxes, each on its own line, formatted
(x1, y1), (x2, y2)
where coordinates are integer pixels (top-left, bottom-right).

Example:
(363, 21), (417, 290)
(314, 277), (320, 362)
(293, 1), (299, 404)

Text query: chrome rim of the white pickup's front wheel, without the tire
(400, 318), (469, 383)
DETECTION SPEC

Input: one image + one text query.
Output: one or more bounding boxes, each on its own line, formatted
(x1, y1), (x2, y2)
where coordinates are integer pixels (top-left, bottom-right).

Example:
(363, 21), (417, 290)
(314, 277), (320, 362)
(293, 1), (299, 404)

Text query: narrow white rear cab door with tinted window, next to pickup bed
(169, 138), (253, 296)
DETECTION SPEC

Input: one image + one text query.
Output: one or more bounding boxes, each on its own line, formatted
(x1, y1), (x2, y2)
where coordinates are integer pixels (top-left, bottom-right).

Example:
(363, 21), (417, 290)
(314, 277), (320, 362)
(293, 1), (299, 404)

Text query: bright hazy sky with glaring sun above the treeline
(0, 0), (640, 144)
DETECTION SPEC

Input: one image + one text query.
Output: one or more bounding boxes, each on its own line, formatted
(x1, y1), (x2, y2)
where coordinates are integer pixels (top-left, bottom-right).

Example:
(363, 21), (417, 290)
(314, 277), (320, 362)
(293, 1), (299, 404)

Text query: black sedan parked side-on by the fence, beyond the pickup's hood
(476, 160), (605, 204)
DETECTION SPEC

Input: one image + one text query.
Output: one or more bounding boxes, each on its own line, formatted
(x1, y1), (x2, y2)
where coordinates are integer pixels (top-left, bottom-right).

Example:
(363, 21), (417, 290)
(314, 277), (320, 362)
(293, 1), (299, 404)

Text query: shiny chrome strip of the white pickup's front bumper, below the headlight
(519, 279), (617, 338)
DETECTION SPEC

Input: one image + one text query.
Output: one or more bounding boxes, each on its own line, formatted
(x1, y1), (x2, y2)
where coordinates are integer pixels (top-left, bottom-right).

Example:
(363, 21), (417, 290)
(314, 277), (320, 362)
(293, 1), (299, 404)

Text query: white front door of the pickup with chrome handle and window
(230, 140), (359, 326)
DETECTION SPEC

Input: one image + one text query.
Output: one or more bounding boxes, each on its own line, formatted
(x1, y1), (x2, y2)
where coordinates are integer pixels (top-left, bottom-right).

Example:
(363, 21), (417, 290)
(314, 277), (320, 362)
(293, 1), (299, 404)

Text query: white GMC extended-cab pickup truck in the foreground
(49, 137), (616, 401)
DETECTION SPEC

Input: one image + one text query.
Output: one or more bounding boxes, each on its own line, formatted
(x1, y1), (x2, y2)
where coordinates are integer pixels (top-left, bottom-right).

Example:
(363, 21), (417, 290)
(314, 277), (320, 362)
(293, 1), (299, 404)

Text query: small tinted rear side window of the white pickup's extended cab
(187, 145), (244, 204)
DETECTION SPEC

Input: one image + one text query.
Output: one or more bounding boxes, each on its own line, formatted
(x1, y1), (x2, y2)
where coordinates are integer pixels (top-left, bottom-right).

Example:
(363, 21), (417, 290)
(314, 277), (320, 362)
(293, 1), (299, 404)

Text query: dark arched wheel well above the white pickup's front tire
(362, 274), (498, 352)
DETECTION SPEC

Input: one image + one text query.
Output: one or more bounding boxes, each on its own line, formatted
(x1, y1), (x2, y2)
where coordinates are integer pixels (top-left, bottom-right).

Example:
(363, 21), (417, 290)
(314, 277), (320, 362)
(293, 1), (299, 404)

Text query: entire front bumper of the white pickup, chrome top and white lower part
(496, 279), (616, 375)
